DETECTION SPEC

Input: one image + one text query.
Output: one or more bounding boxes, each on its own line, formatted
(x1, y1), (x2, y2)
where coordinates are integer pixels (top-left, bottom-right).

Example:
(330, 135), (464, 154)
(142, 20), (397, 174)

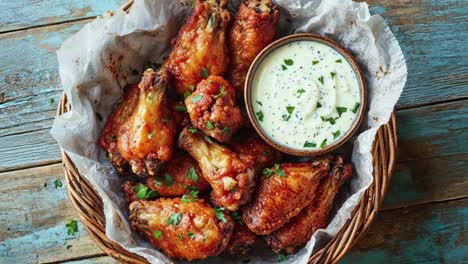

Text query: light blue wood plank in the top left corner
(0, 0), (121, 32)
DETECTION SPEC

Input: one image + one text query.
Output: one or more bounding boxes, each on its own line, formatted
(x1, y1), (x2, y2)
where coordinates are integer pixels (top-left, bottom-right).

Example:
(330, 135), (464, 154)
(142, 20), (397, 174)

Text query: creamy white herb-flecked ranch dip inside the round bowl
(251, 40), (361, 150)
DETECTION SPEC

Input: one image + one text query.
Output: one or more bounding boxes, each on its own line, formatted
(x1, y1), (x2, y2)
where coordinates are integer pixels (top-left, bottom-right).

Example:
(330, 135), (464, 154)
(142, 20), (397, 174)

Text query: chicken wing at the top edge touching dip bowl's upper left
(228, 0), (279, 97)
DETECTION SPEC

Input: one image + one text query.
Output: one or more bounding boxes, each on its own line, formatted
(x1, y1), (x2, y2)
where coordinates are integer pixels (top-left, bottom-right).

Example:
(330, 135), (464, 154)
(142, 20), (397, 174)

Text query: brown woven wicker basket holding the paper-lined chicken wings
(57, 0), (397, 263)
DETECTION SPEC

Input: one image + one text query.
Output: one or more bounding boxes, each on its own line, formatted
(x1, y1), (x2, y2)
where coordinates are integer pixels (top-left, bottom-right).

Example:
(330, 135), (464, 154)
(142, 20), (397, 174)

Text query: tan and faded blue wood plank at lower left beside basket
(0, 164), (106, 263)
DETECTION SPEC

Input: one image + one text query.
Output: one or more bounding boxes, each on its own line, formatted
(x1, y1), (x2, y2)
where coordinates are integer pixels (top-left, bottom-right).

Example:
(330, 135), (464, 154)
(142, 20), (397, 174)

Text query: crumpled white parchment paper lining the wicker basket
(51, 0), (407, 263)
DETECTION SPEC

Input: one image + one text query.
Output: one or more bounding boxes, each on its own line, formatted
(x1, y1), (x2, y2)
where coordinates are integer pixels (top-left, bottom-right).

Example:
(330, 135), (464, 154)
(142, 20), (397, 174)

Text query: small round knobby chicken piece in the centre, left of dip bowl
(185, 75), (244, 142)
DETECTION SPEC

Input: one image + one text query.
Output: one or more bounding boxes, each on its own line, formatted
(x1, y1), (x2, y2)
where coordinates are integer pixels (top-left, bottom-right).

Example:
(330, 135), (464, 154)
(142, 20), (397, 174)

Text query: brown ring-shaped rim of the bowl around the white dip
(244, 33), (368, 156)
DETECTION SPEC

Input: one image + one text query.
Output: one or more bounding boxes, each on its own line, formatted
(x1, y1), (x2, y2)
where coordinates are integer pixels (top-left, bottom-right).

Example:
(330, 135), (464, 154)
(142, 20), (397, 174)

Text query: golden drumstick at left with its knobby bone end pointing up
(117, 69), (175, 177)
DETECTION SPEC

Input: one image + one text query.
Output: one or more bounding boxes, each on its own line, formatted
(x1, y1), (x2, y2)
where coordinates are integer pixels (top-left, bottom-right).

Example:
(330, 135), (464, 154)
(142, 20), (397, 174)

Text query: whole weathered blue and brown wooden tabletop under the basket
(0, 0), (468, 263)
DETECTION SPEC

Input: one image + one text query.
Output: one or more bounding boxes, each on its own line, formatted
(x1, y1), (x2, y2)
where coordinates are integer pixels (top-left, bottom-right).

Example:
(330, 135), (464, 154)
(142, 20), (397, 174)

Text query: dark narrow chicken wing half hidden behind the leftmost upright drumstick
(99, 84), (140, 175)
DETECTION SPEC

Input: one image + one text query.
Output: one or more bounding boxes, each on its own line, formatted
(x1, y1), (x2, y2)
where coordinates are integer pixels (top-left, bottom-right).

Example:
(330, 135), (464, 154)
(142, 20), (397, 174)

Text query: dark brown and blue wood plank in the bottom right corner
(341, 199), (468, 263)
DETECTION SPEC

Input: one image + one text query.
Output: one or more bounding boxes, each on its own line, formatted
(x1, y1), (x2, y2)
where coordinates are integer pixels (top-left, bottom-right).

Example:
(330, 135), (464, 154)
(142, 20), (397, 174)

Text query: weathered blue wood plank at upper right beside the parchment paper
(366, 0), (468, 108)
